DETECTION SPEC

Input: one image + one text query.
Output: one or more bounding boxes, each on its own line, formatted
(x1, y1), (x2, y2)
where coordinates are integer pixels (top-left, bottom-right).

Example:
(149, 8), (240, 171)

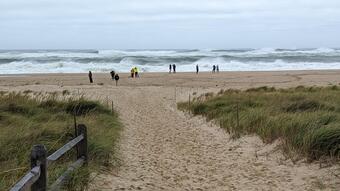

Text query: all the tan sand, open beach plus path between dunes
(0, 70), (340, 190)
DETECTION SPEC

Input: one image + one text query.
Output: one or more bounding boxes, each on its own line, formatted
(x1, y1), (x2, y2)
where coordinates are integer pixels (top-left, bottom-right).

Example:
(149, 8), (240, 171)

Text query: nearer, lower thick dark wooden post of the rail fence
(31, 145), (47, 191)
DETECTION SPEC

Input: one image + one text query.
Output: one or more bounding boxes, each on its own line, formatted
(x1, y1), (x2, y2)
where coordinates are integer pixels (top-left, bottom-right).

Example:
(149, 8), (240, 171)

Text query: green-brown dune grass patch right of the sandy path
(178, 86), (340, 161)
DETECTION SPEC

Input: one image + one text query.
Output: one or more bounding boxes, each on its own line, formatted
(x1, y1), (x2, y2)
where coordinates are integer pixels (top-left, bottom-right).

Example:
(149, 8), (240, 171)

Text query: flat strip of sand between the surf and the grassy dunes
(0, 70), (340, 90)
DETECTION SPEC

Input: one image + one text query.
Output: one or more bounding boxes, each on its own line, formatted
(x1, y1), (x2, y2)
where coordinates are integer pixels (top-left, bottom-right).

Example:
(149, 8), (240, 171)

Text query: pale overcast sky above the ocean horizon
(0, 0), (340, 49)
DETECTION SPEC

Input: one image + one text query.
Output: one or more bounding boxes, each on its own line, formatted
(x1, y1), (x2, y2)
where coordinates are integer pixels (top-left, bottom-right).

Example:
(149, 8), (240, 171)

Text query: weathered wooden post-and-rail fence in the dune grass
(10, 124), (88, 191)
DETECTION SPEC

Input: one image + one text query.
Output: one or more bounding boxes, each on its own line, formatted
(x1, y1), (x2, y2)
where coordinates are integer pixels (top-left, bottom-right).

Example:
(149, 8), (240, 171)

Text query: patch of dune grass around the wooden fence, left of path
(0, 91), (121, 190)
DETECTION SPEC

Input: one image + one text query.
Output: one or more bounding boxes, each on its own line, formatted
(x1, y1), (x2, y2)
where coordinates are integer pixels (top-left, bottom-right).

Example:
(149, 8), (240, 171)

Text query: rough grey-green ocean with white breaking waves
(0, 48), (340, 74)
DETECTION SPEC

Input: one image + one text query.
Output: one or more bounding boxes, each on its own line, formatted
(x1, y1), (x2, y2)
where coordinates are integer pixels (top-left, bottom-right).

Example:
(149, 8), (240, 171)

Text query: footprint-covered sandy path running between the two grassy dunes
(89, 87), (339, 190)
